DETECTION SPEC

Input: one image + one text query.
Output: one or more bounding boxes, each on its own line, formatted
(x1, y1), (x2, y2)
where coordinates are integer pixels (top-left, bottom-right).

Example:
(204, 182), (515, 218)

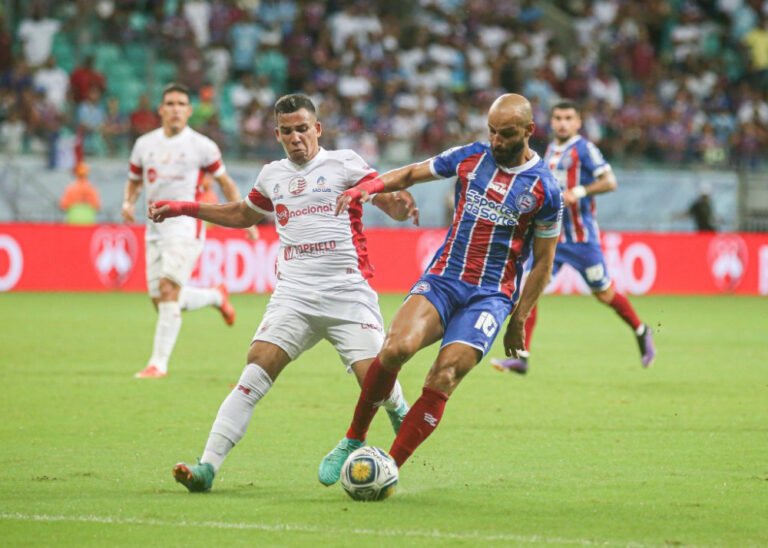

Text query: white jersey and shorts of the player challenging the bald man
(245, 148), (383, 367)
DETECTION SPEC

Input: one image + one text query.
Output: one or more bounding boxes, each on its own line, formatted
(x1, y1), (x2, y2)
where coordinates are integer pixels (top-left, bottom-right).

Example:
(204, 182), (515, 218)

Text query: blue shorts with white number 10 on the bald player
(409, 274), (512, 356)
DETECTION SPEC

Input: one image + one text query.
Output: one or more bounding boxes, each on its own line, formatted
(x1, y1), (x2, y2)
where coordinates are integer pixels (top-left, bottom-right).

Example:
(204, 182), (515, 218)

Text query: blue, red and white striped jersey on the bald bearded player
(426, 142), (562, 297)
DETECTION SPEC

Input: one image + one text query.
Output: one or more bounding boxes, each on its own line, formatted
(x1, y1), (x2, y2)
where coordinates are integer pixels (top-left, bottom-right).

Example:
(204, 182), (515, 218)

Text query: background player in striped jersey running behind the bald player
(491, 101), (656, 374)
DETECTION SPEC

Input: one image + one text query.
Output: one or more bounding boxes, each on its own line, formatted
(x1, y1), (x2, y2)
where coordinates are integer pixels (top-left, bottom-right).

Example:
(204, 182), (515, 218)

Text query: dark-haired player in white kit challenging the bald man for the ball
(149, 94), (418, 492)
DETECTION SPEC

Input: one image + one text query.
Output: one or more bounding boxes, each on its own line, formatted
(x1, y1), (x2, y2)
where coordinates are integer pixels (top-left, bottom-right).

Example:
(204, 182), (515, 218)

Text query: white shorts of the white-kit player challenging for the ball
(253, 283), (384, 371)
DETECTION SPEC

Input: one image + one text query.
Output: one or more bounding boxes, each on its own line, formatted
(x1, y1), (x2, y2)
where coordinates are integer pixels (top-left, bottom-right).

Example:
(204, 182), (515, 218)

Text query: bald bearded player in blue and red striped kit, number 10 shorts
(318, 94), (563, 485)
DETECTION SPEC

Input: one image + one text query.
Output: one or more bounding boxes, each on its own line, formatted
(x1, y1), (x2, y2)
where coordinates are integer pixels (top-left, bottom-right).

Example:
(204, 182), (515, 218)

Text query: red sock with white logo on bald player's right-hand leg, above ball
(390, 386), (448, 468)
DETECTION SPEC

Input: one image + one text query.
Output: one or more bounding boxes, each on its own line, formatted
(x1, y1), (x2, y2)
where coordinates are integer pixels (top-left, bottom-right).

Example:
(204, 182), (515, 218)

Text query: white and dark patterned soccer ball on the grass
(341, 447), (398, 501)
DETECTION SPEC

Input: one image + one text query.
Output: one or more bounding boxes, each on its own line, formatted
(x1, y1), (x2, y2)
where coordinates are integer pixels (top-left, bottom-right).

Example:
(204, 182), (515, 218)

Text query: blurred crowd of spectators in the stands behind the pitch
(0, 0), (768, 168)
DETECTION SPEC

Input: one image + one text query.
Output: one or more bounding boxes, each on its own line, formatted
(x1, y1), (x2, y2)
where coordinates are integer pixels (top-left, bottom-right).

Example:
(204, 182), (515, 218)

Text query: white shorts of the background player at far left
(146, 238), (203, 297)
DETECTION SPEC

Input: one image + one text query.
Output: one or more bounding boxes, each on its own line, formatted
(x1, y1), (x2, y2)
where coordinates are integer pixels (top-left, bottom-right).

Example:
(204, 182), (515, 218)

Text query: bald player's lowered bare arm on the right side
(504, 237), (557, 357)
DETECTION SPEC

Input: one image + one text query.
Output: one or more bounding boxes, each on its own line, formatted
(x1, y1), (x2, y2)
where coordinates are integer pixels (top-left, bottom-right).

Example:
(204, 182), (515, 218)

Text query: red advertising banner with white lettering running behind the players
(0, 224), (768, 295)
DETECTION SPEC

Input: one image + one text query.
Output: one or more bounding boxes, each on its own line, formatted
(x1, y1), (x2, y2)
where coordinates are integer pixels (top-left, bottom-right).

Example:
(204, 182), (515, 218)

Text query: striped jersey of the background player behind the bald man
(544, 135), (611, 245)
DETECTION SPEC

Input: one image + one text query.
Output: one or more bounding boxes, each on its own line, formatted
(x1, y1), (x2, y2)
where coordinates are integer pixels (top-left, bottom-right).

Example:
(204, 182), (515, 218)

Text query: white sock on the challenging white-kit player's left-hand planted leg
(200, 363), (272, 472)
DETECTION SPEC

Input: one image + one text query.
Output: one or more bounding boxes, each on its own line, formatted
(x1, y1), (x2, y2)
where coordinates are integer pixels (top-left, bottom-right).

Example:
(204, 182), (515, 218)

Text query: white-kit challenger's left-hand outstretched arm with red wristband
(147, 200), (264, 228)
